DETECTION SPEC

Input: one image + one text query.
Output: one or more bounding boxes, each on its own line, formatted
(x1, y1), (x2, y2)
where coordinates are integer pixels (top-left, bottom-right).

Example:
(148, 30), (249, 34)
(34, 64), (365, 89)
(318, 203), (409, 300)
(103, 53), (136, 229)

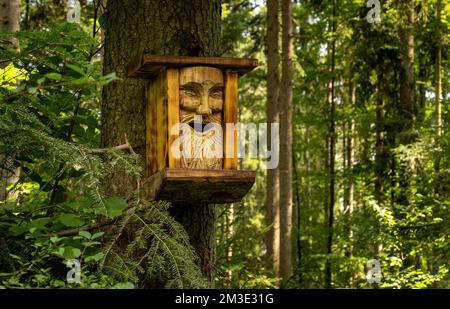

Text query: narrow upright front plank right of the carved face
(223, 70), (238, 169)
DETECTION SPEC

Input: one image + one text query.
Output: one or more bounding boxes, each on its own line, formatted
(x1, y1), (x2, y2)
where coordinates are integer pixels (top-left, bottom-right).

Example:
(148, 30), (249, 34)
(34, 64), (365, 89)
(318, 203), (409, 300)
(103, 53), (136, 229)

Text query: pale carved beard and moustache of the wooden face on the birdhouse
(180, 114), (223, 170)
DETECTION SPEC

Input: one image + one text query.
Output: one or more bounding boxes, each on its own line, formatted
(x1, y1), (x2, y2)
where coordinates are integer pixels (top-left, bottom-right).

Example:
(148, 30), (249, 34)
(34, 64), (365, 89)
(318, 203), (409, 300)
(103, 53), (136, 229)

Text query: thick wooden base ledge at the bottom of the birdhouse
(145, 168), (256, 205)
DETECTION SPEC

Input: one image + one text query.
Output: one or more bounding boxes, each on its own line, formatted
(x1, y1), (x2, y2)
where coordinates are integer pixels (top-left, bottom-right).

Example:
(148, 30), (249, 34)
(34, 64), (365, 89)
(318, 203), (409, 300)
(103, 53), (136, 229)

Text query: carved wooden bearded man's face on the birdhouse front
(180, 67), (223, 169)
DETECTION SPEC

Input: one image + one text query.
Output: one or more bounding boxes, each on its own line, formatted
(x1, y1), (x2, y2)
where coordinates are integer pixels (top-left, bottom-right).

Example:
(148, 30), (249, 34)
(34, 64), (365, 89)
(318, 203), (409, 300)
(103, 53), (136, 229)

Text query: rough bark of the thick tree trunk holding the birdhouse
(102, 0), (221, 286)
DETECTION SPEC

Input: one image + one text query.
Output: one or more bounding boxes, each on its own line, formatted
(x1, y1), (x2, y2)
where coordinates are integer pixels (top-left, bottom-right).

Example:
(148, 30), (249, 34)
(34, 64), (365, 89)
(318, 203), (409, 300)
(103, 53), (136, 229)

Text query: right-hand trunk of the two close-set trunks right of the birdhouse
(279, 0), (294, 279)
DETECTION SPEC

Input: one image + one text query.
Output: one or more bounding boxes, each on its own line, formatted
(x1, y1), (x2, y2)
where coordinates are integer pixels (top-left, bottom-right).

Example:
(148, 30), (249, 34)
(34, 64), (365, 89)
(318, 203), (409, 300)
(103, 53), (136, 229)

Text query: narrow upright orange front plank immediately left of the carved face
(167, 69), (181, 168)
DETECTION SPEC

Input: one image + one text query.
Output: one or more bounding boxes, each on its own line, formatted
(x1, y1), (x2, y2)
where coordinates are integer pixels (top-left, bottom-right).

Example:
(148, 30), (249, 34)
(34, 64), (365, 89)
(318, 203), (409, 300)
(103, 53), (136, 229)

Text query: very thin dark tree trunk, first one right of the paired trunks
(325, 1), (336, 289)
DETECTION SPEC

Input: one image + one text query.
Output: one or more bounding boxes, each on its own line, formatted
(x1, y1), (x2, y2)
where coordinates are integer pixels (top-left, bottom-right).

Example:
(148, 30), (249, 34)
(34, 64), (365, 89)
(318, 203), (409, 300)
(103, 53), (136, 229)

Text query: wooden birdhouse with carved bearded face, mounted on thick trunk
(128, 54), (257, 204)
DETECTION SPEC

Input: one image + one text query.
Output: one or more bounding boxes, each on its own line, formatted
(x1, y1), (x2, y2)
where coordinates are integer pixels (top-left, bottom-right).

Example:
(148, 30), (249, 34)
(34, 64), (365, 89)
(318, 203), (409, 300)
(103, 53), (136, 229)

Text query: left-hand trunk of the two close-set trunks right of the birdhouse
(266, 0), (280, 277)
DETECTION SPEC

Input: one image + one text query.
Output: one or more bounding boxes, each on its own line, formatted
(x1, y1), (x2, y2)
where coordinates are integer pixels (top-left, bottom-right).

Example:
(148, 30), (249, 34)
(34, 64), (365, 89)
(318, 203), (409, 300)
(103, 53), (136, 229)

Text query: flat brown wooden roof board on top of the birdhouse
(127, 54), (258, 79)
